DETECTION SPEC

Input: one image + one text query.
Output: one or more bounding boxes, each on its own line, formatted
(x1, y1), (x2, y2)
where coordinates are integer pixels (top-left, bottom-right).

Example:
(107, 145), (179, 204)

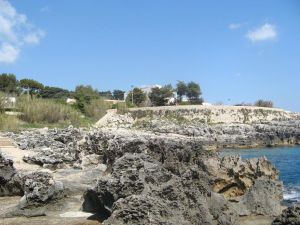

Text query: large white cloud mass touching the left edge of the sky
(0, 0), (45, 63)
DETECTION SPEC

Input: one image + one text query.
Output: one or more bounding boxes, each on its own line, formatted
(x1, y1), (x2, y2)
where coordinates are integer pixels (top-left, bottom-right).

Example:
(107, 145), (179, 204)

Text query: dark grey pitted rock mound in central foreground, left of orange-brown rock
(83, 153), (237, 224)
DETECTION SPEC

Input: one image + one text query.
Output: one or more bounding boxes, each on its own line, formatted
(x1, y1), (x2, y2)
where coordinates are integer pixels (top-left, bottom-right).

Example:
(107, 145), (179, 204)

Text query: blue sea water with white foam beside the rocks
(221, 146), (300, 202)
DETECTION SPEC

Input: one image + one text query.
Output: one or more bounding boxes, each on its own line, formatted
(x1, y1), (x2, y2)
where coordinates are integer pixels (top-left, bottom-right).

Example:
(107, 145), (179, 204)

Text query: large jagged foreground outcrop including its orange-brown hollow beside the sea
(81, 130), (282, 224)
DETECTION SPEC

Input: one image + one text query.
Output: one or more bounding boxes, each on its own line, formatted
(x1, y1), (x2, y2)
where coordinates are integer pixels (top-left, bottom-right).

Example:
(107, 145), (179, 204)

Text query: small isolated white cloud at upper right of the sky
(246, 23), (277, 42)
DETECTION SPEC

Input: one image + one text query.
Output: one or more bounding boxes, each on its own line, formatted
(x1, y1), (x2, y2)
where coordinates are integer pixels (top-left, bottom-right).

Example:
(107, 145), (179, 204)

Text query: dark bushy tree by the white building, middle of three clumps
(149, 84), (173, 106)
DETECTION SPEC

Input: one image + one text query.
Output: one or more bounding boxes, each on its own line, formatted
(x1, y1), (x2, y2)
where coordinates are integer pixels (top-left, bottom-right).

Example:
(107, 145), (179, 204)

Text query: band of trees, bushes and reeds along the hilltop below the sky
(0, 73), (273, 130)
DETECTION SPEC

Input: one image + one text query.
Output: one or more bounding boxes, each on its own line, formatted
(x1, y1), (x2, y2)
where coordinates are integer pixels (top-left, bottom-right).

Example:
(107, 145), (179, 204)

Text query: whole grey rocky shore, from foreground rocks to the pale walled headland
(0, 107), (300, 225)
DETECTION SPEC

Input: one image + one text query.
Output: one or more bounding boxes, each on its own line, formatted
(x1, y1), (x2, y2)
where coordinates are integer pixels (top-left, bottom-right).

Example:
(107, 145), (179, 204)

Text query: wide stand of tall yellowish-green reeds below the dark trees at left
(17, 98), (83, 126)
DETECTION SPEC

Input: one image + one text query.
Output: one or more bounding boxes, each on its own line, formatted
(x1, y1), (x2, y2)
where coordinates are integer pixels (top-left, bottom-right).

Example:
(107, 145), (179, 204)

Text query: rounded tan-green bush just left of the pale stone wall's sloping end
(84, 98), (112, 120)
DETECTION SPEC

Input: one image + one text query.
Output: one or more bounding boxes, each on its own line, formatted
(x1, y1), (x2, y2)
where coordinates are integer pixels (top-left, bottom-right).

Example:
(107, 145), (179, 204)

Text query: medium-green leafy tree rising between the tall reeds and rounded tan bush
(74, 85), (100, 113)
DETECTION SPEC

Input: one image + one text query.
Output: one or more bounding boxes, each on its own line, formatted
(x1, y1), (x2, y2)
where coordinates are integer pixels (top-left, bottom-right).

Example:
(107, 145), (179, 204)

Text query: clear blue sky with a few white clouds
(0, 0), (300, 112)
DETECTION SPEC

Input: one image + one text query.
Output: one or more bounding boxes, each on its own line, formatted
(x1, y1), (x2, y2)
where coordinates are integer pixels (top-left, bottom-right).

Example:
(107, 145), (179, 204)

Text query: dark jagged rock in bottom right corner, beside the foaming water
(272, 205), (300, 225)
